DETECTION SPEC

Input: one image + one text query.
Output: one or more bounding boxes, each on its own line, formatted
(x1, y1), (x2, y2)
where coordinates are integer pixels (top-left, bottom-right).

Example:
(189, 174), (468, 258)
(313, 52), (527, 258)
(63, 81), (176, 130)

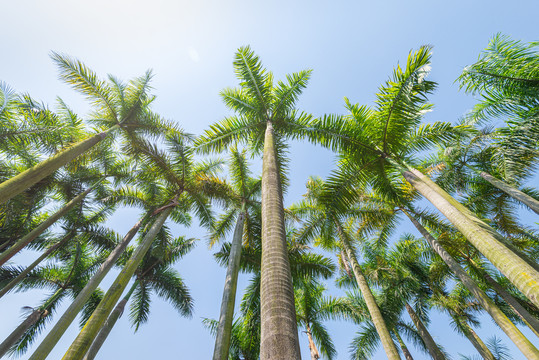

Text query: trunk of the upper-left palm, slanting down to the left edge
(0, 126), (118, 204)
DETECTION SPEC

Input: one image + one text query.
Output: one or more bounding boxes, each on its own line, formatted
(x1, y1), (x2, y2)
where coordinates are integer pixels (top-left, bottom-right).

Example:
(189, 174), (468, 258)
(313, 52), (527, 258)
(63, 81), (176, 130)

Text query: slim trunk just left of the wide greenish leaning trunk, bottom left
(29, 214), (149, 360)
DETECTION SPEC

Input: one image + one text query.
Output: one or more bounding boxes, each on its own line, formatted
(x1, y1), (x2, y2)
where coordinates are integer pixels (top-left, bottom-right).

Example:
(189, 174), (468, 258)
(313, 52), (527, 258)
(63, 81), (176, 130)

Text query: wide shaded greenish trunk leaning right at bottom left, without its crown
(62, 205), (177, 360)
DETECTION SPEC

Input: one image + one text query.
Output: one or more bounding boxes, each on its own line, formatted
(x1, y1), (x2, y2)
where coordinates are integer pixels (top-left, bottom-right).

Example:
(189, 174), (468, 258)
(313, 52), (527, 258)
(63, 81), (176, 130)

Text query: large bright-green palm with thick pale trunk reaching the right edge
(310, 46), (539, 305)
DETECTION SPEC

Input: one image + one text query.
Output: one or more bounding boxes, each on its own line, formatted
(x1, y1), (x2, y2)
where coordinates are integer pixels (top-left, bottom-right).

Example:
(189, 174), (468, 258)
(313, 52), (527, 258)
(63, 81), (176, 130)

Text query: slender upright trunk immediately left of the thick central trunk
(213, 210), (245, 360)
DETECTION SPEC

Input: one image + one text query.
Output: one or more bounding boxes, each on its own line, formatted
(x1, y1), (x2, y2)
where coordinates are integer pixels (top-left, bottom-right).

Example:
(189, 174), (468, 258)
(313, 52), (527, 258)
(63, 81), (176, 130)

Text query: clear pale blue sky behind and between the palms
(0, 0), (539, 359)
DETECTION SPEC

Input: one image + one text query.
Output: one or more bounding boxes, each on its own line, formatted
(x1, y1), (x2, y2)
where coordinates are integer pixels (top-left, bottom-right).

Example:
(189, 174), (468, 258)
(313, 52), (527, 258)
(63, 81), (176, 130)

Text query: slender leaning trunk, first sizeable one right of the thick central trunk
(336, 223), (400, 360)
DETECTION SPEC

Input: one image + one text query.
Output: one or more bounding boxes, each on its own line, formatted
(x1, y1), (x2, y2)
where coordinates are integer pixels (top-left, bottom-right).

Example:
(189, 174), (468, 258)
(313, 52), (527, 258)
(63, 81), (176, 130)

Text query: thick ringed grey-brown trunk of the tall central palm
(260, 122), (301, 360)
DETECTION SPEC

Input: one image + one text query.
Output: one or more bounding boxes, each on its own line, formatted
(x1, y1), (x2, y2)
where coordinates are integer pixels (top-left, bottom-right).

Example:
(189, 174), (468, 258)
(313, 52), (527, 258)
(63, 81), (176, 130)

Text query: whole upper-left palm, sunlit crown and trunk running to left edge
(0, 53), (174, 204)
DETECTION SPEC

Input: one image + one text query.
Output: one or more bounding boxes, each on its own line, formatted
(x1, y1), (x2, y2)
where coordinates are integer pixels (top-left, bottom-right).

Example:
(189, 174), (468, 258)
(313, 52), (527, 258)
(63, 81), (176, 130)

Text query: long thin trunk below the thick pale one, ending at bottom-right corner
(403, 211), (539, 359)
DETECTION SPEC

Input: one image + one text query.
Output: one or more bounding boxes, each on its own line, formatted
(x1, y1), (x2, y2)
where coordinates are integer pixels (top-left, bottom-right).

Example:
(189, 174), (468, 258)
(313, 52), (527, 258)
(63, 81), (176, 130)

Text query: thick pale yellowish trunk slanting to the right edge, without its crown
(403, 168), (539, 306)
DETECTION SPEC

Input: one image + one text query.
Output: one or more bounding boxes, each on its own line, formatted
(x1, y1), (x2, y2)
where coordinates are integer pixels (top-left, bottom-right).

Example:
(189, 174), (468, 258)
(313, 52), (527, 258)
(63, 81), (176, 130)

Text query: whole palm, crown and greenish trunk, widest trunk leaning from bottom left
(60, 134), (217, 360)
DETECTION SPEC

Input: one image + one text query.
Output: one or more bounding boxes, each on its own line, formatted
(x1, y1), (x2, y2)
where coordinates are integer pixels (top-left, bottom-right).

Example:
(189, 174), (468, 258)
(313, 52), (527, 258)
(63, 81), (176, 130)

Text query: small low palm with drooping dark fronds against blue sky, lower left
(84, 234), (195, 360)
